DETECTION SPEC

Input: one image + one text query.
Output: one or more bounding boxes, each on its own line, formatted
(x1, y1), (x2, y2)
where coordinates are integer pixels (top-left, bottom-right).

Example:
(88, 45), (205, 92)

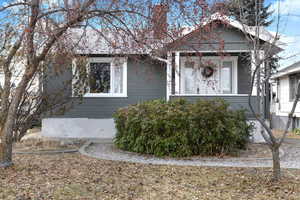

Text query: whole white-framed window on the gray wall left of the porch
(74, 57), (127, 97)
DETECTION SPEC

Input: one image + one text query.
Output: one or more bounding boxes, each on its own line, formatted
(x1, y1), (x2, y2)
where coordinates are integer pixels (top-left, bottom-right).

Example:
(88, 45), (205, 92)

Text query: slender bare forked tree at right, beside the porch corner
(236, 0), (300, 181)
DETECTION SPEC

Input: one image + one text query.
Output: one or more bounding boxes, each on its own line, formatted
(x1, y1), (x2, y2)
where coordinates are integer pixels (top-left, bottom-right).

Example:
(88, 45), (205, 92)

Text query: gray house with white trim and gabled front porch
(42, 12), (281, 141)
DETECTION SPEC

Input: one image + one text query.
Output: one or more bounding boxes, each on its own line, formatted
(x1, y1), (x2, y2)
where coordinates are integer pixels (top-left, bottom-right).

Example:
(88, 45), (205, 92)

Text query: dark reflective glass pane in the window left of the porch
(90, 63), (111, 93)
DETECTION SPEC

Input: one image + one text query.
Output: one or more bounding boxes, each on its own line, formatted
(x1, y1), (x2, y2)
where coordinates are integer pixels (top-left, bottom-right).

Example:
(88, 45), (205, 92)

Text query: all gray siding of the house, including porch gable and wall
(44, 26), (256, 118)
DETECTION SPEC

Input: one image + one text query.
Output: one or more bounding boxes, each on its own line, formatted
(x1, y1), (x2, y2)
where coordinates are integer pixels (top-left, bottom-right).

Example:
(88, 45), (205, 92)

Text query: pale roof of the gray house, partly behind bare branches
(71, 13), (284, 54)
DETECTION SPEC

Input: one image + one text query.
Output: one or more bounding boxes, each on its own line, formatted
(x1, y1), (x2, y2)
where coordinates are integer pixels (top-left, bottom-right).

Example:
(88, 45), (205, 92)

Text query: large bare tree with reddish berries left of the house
(0, 0), (216, 167)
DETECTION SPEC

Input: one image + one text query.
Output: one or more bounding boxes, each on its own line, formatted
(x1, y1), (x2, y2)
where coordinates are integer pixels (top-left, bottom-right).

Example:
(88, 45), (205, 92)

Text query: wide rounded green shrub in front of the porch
(114, 99), (252, 157)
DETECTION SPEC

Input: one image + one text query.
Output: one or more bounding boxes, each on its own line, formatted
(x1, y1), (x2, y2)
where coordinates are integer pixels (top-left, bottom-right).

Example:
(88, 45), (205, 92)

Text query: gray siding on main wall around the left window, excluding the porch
(44, 56), (166, 119)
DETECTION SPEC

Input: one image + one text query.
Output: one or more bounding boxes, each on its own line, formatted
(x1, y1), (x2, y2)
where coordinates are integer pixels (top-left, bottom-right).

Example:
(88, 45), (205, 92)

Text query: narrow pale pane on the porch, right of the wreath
(221, 61), (232, 93)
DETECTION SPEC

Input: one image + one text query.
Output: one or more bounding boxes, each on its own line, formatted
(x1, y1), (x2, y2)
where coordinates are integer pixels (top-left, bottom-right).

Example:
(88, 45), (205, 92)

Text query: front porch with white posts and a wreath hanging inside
(167, 51), (258, 119)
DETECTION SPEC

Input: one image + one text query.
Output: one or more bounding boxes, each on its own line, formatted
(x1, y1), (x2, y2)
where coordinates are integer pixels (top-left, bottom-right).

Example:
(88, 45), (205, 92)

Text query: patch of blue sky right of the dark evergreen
(265, 0), (300, 68)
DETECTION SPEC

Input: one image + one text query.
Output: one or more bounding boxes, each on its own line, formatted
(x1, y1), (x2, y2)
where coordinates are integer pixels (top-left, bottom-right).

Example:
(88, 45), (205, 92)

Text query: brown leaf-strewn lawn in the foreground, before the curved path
(0, 153), (300, 200)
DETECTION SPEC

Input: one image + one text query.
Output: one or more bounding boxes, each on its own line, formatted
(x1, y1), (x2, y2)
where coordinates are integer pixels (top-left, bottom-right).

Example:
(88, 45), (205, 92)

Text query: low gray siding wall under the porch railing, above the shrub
(170, 96), (257, 119)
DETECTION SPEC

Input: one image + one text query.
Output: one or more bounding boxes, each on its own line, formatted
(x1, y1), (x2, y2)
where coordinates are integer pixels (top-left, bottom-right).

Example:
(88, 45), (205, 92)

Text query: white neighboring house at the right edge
(271, 62), (300, 130)
